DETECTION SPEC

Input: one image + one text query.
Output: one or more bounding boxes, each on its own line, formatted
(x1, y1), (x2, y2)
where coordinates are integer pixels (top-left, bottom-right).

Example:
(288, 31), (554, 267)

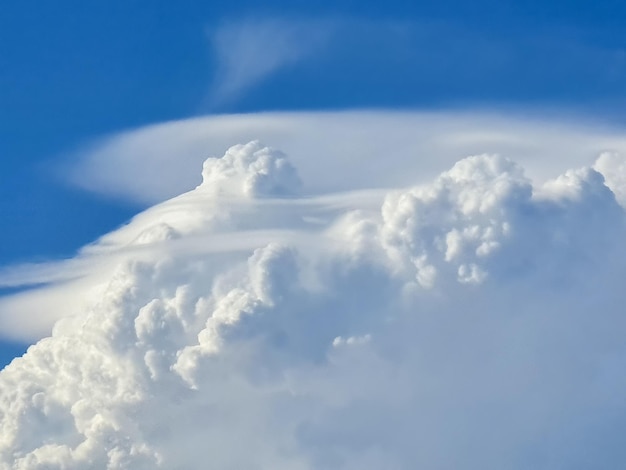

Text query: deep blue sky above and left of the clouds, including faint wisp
(0, 0), (626, 364)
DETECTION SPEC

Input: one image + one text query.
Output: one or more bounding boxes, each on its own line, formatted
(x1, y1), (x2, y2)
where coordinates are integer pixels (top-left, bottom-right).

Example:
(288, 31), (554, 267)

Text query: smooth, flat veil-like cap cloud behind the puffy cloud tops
(60, 111), (626, 204)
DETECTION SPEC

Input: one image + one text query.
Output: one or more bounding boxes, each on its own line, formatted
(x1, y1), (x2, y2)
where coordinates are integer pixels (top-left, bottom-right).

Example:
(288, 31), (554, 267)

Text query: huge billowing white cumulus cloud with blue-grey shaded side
(0, 142), (626, 470)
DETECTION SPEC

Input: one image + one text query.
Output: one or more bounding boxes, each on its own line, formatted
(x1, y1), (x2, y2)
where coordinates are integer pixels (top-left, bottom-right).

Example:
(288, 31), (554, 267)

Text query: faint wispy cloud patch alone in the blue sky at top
(209, 18), (333, 105)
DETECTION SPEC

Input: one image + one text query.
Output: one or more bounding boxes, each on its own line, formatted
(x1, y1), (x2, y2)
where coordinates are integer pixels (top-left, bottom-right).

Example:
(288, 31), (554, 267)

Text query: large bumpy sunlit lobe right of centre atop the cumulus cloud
(383, 155), (532, 288)
